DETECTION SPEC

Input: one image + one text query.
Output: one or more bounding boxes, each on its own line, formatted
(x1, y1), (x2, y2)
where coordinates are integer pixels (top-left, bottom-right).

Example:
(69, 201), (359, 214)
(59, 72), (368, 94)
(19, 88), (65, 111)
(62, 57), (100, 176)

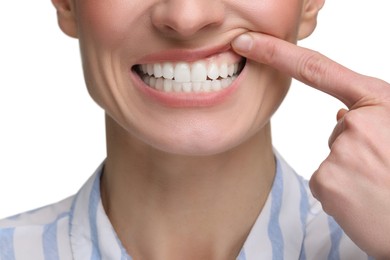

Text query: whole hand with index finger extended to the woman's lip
(232, 33), (390, 259)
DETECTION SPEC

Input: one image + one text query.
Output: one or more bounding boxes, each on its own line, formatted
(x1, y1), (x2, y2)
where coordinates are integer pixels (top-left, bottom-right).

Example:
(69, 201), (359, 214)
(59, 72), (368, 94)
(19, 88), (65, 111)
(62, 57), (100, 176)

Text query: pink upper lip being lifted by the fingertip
(136, 43), (236, 64)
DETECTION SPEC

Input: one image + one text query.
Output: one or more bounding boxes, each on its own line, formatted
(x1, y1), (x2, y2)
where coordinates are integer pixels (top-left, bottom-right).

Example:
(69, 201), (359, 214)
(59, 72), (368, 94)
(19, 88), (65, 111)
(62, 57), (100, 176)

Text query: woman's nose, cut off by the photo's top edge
(152, 0), (225, 38)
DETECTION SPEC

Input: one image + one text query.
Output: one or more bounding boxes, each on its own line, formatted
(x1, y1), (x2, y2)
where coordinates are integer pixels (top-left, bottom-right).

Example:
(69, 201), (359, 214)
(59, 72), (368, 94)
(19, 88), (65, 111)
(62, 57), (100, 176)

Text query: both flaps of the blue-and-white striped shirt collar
(69, 152), (308, 260)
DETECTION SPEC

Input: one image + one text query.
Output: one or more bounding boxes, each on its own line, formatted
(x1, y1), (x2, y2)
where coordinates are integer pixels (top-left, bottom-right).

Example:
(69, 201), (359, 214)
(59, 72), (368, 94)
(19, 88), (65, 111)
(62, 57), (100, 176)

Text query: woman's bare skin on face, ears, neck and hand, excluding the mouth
(52, 0), (390, 259)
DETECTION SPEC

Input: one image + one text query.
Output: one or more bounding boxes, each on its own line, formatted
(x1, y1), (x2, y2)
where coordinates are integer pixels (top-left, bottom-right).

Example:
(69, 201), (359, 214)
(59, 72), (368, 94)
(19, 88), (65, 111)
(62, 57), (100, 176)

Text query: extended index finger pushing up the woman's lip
(232, 33), (379, 108)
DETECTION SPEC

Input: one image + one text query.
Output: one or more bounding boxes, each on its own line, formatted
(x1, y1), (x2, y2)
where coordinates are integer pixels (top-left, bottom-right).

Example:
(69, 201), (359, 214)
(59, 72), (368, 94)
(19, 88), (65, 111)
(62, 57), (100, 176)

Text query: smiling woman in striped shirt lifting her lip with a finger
(0, 0), (390, 259)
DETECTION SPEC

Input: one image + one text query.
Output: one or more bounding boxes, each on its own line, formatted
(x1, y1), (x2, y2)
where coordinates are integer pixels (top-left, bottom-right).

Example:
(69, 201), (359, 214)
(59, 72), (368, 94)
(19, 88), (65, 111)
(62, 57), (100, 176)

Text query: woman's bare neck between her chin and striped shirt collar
(101, 115), (275, 259)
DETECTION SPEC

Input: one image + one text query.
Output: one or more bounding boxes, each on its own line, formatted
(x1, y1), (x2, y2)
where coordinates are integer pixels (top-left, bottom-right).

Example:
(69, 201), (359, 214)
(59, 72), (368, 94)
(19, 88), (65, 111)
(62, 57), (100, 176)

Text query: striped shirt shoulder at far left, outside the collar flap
(0, 197), (74, 259)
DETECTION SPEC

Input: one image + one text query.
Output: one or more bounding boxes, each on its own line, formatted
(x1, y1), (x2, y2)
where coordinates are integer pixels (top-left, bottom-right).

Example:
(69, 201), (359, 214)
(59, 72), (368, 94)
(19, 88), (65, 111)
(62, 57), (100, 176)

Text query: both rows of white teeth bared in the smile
(139, 61), (239, 92)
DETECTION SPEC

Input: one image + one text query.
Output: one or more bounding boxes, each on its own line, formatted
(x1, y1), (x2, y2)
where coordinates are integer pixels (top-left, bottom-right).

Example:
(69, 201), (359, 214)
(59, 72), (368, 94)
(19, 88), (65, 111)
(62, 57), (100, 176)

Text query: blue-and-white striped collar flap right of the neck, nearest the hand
(238, 151), (309, 260)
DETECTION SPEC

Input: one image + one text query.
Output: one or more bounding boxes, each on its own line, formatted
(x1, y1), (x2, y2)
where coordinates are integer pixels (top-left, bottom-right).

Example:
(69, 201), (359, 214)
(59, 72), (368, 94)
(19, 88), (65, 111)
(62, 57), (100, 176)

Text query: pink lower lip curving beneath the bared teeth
(130, 66), (245, 108)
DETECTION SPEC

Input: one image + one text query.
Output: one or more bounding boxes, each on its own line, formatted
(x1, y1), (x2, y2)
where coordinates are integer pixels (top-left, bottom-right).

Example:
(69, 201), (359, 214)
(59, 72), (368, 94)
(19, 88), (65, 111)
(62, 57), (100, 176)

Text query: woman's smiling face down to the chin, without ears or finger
(66, 0), (316, 155)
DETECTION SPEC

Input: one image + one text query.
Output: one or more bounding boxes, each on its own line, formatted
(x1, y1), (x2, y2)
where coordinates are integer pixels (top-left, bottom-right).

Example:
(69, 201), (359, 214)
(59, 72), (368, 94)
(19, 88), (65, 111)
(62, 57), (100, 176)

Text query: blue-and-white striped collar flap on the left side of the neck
(69, 164), (131, 260)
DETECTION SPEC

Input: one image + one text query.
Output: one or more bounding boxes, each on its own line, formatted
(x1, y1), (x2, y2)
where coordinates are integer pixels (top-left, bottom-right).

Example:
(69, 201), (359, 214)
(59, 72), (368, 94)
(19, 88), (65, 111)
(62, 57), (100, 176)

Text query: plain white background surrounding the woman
(0, 0), (390, 218)
